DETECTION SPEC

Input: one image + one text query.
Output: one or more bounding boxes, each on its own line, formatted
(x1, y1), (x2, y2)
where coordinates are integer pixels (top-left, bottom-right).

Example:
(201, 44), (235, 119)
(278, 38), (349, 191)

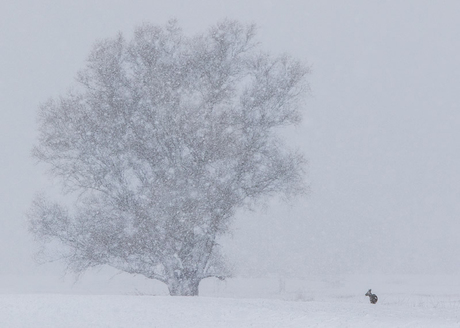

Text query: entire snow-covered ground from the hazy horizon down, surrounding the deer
(0, 276), (460, 328)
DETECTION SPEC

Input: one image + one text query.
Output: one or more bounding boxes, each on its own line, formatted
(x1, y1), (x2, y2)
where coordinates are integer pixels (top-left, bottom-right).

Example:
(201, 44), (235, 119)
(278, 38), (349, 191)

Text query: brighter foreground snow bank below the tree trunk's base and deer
(0, 294), (460, 328)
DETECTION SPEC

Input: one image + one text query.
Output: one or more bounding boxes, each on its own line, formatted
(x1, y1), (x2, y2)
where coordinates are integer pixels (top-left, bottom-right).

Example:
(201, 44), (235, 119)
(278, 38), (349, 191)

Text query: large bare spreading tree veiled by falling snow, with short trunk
(29, 20), (308, 295)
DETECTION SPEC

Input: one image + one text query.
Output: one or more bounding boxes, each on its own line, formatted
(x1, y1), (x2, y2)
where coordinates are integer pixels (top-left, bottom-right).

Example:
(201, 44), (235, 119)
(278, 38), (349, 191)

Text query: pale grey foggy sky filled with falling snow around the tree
(0, 0), (460, 288)
